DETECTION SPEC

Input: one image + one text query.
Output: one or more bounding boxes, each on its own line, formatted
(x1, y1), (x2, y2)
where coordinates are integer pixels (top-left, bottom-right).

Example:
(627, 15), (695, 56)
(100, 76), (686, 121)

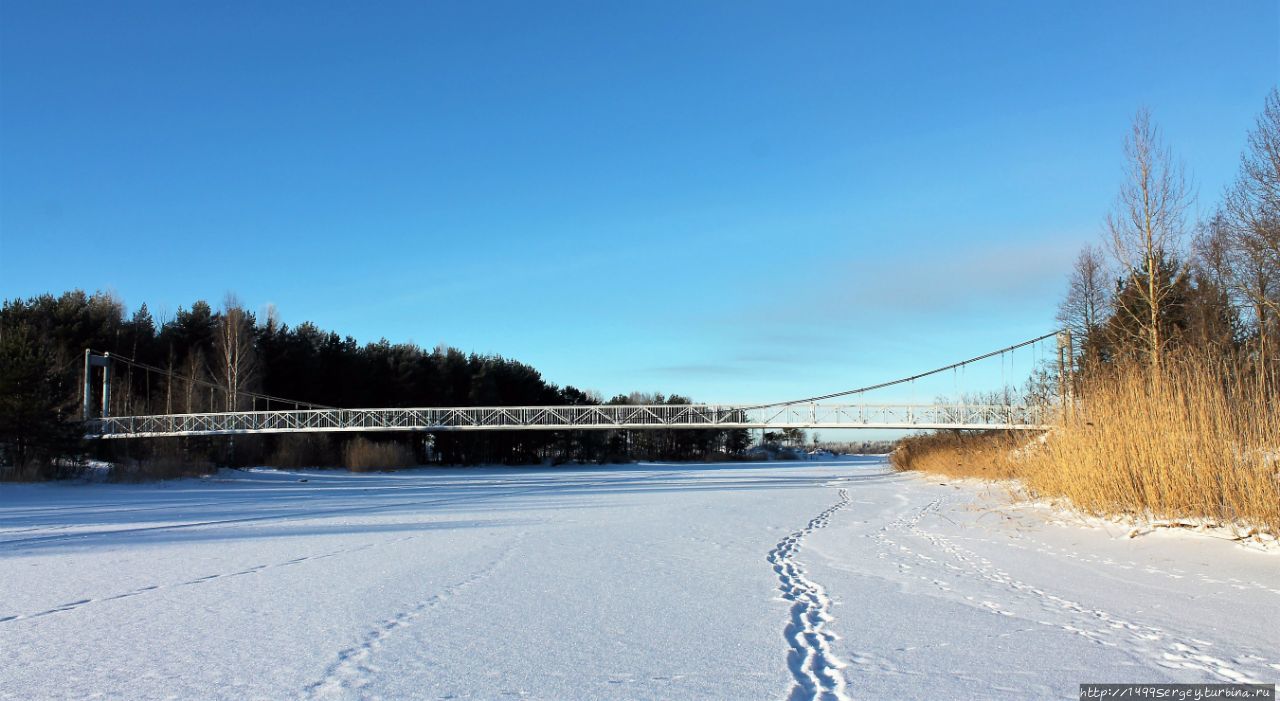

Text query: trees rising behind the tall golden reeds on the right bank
(1057, 88), (1280, 388)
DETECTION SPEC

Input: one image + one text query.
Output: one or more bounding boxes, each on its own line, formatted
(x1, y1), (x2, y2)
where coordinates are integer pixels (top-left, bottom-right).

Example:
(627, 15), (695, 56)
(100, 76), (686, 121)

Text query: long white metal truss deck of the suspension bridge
(86, 403), (1050, 439)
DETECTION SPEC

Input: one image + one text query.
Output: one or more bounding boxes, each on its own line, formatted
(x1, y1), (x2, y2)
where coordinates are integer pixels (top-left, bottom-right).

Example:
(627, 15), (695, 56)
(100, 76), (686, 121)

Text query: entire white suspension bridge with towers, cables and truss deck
(74, 331), (1070, 439)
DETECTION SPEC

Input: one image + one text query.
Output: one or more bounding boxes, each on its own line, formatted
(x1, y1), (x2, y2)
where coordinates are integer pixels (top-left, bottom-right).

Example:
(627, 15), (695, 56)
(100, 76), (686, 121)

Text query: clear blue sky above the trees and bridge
(0, 1), (1280, 402)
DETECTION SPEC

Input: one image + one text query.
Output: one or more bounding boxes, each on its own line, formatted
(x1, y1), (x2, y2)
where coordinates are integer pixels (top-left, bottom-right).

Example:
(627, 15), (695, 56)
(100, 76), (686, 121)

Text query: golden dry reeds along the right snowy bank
(893, 358), (1280, 533)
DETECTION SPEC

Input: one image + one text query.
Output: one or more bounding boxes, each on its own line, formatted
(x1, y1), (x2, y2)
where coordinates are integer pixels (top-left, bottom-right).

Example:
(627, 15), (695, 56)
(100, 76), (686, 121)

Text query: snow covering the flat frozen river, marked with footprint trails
(0, 457), (1280, 700)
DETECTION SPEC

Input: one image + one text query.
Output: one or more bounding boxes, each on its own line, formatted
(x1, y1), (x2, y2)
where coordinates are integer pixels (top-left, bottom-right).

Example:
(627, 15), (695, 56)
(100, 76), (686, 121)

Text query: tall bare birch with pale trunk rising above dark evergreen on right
(1107, 109), (1189, 374)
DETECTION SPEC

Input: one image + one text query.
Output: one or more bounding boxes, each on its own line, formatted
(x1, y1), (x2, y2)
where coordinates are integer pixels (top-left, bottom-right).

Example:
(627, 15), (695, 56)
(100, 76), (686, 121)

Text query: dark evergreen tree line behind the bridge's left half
(0, 290), (749, 477)
